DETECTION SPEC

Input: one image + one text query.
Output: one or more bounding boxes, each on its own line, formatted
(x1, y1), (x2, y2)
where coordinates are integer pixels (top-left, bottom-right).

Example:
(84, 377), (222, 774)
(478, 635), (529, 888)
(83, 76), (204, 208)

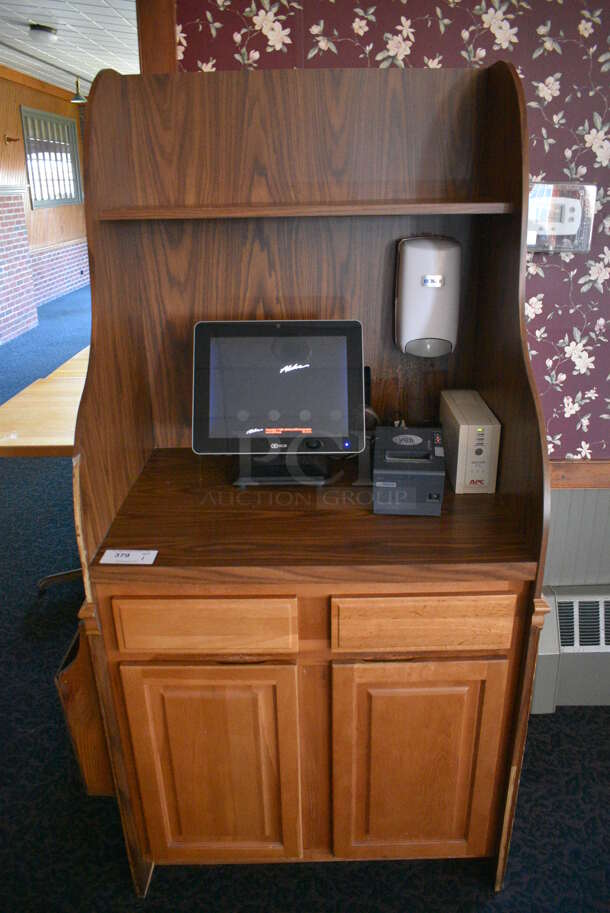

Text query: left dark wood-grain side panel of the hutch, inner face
(74, 72), (152, 560)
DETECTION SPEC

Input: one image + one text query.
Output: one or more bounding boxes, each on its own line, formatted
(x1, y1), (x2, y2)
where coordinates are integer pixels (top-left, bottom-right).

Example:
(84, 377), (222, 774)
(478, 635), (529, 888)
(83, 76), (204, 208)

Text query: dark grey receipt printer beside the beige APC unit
(373, 428), (445, 517)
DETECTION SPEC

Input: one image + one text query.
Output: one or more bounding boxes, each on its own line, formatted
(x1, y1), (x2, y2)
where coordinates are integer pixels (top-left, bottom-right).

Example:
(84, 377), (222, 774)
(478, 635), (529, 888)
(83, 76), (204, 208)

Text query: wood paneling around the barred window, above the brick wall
(0, 69), (85, 247)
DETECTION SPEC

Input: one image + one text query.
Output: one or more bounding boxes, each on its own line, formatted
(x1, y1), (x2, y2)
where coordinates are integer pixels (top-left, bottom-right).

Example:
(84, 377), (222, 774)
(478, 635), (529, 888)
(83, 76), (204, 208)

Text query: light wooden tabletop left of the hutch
(0, 346), (89, 457)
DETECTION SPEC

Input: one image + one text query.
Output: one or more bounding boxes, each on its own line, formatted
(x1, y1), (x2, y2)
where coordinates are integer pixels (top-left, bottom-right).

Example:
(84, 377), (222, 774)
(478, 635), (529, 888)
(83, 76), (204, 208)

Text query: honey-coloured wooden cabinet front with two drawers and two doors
(108, 581), (523, 863)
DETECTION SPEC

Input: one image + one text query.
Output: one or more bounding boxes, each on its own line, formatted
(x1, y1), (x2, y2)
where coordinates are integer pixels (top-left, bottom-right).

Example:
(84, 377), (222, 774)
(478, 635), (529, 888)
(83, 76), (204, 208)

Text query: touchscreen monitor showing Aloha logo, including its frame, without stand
(193, 320), (364, 453)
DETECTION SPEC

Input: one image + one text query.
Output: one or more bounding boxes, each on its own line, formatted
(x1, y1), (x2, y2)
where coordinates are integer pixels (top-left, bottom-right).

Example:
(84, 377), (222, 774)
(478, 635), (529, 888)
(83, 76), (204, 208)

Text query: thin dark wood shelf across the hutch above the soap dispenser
(99, 200), (515, 222)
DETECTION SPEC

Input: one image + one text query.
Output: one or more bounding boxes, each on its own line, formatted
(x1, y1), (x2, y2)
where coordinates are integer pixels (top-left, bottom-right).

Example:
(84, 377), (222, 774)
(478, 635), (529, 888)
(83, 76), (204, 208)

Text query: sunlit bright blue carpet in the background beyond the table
(0, 285), (91, 403)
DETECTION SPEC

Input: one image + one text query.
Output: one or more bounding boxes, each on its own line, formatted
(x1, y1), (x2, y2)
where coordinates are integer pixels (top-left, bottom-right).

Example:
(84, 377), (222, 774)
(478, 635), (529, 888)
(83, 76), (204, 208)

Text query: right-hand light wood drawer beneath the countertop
(331, 593), (517, 653)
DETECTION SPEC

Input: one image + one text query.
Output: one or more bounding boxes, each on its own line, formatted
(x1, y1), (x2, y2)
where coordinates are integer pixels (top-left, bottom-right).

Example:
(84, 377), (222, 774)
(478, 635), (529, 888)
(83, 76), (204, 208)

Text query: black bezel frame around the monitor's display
(192, 320), (365, 456)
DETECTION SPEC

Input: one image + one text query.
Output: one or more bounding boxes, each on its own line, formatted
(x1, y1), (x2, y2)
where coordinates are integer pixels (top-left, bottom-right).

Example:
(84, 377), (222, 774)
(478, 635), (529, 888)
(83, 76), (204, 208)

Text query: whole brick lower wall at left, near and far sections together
(0, 192), (89, 345)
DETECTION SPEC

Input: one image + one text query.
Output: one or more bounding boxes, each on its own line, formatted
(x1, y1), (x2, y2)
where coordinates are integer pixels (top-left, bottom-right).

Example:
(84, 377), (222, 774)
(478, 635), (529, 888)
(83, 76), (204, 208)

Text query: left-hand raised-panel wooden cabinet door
(121, 665), (301, 862)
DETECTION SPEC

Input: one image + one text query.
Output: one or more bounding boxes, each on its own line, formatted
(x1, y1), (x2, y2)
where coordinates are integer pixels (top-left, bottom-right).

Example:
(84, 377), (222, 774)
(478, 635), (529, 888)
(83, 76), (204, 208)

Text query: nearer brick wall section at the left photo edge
(0, 193), (38, 344)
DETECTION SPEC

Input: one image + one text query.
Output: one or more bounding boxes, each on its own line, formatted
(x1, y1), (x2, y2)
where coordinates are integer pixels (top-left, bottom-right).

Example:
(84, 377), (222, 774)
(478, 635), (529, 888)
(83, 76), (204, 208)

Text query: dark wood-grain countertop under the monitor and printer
(95, 448), (535, 577)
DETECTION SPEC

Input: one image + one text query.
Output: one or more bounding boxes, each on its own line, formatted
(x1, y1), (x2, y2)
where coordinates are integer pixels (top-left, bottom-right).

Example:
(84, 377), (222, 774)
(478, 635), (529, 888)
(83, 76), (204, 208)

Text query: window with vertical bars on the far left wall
(21, 107), (83, 209)
